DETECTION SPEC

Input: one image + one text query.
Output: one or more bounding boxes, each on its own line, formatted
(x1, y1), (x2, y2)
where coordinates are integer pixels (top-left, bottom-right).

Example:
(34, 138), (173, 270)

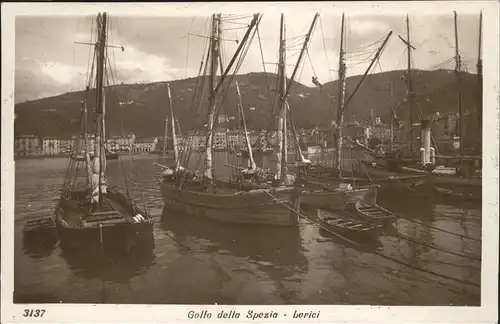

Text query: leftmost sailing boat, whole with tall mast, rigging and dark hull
(55, 13), (153, 250)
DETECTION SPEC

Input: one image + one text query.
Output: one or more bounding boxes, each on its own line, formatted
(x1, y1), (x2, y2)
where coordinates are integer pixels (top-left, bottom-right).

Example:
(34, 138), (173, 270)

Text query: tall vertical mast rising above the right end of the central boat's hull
(276, 14), (288, 181)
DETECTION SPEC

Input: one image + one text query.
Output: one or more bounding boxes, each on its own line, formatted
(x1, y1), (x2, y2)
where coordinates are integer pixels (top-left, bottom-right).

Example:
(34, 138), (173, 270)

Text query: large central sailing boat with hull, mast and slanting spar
(158, 14), (301, 226)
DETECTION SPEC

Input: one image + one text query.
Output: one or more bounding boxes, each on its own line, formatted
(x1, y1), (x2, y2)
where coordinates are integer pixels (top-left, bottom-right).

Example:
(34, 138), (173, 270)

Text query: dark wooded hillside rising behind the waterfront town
(14, 70), (477, 137)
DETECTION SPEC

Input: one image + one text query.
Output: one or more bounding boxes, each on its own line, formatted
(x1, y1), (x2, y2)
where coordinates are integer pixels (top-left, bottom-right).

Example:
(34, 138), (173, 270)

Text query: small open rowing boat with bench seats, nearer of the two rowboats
(317, 209), (382, 238)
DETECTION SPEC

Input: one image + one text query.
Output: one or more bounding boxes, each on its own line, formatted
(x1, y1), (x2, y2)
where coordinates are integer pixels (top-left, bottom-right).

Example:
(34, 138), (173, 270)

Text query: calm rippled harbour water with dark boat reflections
(14, 154), (481, 306)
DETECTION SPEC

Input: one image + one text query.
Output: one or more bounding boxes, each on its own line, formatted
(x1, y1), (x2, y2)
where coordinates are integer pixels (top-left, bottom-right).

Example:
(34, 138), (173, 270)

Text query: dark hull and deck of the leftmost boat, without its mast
(55, 190), (153, 252)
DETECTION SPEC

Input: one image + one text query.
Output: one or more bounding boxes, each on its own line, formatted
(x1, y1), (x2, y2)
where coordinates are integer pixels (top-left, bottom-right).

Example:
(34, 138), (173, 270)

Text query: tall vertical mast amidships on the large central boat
(204, 14), (221, 179)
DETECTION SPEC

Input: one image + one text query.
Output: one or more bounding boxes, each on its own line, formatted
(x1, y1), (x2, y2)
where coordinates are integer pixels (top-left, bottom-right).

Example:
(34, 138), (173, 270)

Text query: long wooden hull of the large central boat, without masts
(160, 181), (300, 226)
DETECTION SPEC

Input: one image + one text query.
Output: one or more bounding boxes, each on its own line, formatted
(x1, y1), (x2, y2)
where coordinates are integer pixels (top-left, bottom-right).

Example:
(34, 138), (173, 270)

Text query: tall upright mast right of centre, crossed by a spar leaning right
(334, 14), (346, 178)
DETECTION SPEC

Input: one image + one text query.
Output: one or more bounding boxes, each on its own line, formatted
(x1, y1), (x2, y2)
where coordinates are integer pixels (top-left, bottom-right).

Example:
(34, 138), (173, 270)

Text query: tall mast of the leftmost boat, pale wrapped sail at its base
(94, 12), (107, 201)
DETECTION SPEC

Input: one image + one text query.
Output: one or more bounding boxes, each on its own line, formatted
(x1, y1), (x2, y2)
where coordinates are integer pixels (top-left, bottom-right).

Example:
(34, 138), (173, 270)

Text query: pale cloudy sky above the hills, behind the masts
(15, 11), (479, 103)
